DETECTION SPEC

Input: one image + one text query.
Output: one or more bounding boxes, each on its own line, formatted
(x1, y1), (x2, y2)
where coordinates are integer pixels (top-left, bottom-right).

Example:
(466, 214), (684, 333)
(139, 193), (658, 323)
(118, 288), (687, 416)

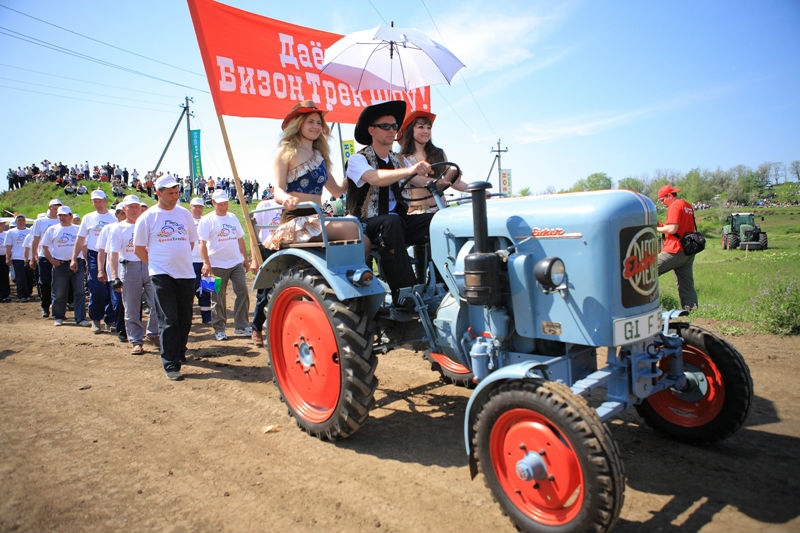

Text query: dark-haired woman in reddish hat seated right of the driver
(396, 111), (466, 214)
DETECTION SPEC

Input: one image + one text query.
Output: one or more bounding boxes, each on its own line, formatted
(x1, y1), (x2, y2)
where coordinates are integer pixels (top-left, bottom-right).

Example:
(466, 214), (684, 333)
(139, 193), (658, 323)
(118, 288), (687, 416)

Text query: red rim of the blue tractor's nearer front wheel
(489, 408), (585, 526)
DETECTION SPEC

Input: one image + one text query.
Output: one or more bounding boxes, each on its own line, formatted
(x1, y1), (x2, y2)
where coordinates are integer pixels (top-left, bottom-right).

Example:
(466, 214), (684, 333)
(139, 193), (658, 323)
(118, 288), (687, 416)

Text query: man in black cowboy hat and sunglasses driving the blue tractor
(346, 101), (433, 306)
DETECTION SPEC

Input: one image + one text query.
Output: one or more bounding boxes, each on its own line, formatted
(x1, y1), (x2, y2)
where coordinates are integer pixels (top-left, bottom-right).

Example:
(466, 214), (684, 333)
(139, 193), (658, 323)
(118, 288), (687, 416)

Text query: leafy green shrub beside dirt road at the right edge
(754, 279), (800, 335)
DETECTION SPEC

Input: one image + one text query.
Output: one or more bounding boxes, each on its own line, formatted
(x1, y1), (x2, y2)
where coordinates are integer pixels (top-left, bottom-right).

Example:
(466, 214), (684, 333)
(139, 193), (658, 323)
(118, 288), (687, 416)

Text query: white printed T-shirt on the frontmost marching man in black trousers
(133, 204), (197, 279)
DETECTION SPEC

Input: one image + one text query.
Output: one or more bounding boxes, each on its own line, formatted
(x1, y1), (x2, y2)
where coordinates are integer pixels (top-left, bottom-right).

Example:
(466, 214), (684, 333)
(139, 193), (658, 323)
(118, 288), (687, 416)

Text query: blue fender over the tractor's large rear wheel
(253, 248), (386, 309)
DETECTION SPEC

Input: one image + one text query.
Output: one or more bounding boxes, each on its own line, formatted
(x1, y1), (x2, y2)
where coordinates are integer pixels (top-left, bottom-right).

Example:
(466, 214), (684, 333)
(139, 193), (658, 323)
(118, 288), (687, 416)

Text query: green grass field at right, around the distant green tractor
(659, 207), (800, 334)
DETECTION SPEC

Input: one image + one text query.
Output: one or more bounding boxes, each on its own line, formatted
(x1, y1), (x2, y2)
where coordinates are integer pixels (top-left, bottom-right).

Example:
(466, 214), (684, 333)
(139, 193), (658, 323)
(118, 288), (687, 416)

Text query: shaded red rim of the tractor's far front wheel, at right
(647, 345), (725, 427)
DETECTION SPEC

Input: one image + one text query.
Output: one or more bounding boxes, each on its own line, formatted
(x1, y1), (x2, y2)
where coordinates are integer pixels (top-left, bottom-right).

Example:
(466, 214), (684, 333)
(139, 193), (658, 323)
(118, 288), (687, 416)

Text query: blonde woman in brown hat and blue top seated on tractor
(264, 100), (367, 250)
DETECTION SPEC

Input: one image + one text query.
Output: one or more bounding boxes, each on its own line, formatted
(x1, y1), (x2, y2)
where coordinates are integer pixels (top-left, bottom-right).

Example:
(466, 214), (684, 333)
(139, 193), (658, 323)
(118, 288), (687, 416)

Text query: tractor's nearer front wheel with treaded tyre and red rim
(473, 381), (625, 533)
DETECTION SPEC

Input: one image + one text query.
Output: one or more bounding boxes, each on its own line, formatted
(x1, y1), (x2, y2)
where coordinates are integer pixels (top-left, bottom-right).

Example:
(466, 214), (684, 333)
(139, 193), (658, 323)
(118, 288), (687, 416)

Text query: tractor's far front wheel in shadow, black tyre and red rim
(636, 322), (753, 444)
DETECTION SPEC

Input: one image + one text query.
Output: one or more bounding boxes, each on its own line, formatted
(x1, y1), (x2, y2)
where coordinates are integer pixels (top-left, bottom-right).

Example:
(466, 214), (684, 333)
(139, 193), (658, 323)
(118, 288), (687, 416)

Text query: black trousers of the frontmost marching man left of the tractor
(150, 274), (194, 372)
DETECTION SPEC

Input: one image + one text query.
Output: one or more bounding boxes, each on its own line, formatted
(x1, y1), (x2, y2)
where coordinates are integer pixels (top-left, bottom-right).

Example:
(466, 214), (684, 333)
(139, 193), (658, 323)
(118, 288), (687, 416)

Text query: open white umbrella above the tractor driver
(321, 26), (464, 91)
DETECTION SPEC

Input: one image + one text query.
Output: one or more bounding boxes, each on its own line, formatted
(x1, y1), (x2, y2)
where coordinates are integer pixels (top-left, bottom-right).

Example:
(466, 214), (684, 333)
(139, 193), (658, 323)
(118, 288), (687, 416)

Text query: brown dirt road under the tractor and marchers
(0, 303), (800, 533)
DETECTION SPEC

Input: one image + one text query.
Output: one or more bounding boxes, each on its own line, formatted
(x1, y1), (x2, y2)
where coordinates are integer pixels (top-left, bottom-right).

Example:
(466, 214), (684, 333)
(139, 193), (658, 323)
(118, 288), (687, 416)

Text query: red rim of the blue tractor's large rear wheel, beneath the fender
(269, 287), (342, 424)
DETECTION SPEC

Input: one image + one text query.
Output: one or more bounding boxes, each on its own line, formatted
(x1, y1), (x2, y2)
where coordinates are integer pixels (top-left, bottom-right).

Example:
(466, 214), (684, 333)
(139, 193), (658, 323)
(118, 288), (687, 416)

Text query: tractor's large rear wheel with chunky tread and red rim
(266, 268), (378, 440)
